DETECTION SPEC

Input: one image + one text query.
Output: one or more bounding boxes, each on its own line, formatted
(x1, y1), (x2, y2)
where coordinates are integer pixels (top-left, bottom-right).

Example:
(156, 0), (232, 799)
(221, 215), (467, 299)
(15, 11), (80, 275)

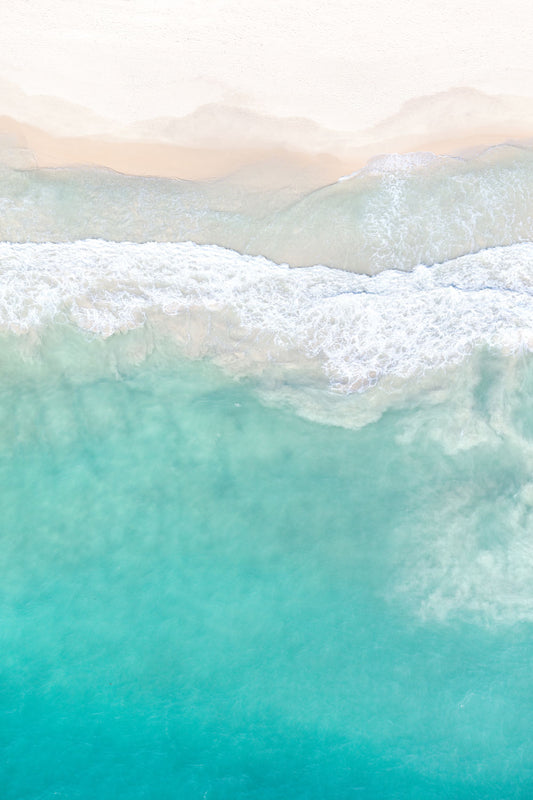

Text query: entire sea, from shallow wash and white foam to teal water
(0, 146), (533, 800)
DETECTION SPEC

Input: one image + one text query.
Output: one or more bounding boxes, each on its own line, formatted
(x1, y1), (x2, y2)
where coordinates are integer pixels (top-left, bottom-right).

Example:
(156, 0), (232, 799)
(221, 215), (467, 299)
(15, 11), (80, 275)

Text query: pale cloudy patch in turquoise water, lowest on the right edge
(393, 462), (533, 623)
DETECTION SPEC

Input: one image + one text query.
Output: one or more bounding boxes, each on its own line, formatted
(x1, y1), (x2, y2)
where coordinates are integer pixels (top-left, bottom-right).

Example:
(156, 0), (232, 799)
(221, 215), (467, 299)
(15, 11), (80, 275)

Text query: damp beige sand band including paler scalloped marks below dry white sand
(0, 91), (533, 186)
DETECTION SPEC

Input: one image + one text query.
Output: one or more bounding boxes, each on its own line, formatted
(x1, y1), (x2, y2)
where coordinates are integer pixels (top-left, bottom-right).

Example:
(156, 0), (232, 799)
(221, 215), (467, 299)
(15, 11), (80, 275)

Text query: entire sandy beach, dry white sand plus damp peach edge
(0, 0), (533, 180)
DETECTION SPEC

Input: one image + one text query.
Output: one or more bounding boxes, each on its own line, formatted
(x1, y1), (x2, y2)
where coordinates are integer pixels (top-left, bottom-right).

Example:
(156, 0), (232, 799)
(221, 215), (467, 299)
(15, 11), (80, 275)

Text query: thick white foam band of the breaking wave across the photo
(0, 240), (533, 394)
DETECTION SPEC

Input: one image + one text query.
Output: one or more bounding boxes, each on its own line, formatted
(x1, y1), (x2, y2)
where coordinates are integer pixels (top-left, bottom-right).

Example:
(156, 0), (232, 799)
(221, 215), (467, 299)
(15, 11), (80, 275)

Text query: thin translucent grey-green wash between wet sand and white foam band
(0, 146), (533, 274)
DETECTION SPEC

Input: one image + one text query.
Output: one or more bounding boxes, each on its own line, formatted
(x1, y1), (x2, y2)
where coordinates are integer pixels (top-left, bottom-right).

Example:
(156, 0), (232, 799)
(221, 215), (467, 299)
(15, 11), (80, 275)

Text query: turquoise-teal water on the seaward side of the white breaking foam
(0, 332), (533, 800)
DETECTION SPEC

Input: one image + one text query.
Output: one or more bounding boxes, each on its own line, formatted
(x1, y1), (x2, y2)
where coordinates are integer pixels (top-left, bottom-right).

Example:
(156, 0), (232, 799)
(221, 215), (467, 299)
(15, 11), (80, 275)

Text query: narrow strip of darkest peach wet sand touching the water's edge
(0, 109), (533, 184)
